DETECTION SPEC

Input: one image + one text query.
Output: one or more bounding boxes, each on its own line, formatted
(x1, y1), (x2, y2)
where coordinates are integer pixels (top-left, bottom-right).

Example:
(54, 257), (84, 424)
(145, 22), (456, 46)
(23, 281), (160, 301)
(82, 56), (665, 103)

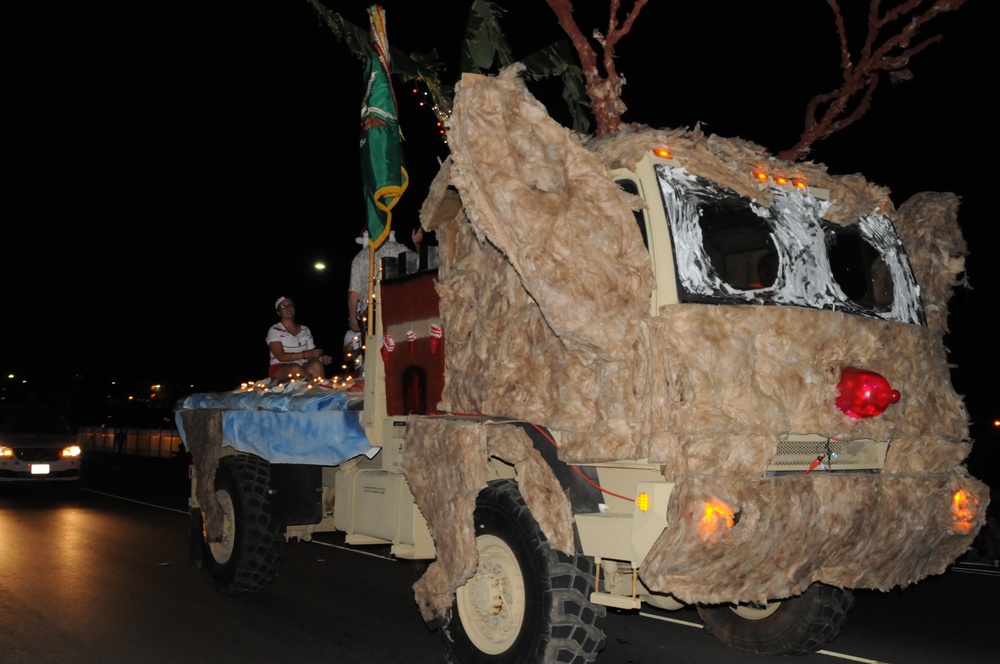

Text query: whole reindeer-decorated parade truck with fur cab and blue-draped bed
(177, 69), (989, 663)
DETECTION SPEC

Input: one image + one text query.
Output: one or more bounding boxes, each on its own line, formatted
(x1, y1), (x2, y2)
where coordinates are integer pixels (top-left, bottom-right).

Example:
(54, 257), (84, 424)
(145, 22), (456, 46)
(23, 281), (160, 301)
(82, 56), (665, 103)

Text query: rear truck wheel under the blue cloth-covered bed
(204, 454), (285, 593)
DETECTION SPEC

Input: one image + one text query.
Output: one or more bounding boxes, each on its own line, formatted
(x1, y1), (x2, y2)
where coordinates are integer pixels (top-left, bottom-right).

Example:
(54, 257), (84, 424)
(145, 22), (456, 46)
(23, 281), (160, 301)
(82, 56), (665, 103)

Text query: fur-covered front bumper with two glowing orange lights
(639, 469), (989, 604)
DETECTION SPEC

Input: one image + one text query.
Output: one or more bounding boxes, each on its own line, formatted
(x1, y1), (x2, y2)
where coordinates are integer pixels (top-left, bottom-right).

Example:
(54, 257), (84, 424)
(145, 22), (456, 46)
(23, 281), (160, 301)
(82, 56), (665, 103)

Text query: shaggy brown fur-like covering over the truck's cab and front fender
(406, 70), (989, 618)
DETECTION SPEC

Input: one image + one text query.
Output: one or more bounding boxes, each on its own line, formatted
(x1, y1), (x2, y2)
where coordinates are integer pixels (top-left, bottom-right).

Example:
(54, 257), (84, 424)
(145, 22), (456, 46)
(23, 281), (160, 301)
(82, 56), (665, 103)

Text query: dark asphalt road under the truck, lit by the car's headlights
(0, 459), (1000, 664)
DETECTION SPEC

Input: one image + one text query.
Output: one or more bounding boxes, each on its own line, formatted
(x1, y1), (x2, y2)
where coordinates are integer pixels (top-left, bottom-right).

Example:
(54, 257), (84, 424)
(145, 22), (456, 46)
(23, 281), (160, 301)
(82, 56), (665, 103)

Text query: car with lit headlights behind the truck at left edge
(0, 403), (82, 483)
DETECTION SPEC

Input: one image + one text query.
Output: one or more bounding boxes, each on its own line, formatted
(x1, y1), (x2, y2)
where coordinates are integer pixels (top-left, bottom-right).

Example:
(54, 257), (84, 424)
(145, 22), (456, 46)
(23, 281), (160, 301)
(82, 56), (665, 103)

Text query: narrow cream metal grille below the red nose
(765, 436), (889, 476)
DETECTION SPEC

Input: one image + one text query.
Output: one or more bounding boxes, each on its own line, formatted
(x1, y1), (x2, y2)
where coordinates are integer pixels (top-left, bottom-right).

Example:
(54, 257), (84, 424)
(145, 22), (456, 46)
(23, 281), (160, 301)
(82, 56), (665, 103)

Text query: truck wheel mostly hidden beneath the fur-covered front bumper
(698, 583), (854, 655)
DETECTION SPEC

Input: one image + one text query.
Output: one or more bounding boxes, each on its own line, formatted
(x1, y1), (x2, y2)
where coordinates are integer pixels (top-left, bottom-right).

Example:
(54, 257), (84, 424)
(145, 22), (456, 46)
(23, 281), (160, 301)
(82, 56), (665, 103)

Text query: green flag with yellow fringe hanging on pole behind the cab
(361, 57), (408, 249)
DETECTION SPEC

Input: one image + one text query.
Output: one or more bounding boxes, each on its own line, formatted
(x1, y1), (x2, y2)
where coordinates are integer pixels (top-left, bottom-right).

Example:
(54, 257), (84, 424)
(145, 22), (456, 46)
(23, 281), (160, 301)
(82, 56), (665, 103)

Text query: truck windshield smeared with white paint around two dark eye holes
(656, 165), (924, 324)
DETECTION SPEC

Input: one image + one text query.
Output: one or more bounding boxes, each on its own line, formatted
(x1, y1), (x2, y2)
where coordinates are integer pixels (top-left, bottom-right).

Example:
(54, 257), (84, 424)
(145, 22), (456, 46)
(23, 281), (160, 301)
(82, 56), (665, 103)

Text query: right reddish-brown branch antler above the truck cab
(778, 0), (965, 161)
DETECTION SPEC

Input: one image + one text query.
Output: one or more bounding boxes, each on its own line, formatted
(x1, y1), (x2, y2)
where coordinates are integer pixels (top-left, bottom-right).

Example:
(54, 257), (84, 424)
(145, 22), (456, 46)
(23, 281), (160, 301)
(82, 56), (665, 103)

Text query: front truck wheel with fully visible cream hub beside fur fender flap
(442, 480), (606, 664)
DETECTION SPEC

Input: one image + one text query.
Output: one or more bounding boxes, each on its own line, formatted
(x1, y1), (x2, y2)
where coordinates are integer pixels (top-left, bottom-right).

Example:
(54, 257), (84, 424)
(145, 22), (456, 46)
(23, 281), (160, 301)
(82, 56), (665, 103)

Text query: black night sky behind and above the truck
(0, 0), (1000, 478)
